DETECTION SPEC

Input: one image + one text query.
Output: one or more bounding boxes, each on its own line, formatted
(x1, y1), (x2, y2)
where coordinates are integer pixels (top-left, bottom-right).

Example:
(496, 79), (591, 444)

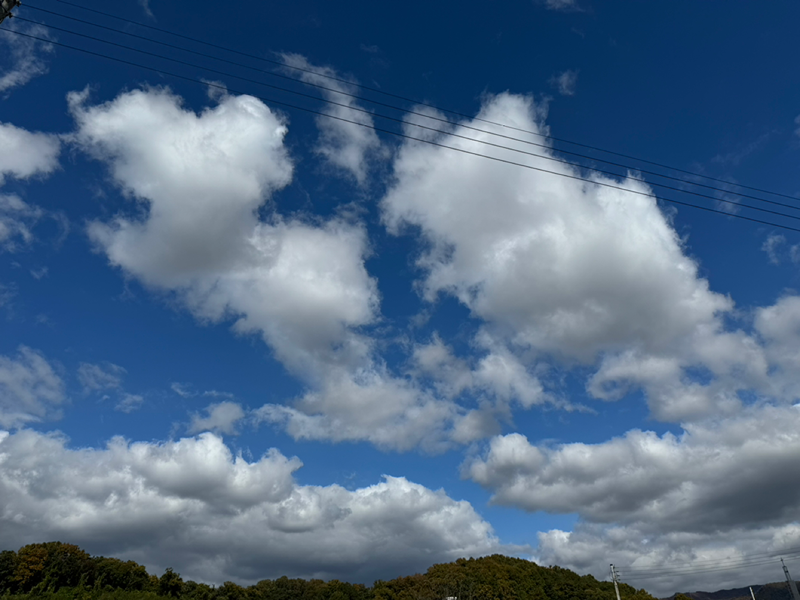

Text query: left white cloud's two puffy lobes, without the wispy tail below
(70, 90), (377, 378)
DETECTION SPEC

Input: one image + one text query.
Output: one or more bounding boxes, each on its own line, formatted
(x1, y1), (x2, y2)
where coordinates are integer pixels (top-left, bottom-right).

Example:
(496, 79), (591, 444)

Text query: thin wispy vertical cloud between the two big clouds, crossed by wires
(282, 54), (386, 185)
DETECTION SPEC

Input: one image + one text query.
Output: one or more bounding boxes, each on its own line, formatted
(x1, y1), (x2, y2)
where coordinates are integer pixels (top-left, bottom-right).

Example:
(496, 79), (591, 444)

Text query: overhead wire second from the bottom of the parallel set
(15, 17), (800, 226)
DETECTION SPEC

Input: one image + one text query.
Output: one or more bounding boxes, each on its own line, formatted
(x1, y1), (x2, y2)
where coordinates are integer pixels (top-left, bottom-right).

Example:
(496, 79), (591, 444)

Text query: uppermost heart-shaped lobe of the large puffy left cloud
(69, 89), (292, 287)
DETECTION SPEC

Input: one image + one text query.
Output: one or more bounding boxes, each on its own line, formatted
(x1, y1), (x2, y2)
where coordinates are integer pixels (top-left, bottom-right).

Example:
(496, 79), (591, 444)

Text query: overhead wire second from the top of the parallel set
(17, 3), (800, 210)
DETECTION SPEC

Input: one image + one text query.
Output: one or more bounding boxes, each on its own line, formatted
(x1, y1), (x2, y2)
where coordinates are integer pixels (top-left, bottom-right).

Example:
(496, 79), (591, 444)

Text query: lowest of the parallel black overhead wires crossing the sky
(6, 27), (800, 233)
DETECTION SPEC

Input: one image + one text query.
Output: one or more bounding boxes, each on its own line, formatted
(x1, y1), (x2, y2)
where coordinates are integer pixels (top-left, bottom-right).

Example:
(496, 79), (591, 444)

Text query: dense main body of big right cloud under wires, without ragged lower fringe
(382, 94), (731, 360)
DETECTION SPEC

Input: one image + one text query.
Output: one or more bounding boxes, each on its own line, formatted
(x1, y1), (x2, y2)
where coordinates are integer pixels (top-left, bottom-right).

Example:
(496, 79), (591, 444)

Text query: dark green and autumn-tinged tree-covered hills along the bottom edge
(0, 542), (653, 600)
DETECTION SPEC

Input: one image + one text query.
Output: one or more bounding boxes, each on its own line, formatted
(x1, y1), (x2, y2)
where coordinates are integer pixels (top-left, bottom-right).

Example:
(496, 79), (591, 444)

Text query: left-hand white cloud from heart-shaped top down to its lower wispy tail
(70, 84), (472, 449)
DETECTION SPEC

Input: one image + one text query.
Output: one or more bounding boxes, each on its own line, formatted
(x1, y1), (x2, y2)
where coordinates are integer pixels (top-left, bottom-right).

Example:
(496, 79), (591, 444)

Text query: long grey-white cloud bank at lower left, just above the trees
(0, 430), (501, 583)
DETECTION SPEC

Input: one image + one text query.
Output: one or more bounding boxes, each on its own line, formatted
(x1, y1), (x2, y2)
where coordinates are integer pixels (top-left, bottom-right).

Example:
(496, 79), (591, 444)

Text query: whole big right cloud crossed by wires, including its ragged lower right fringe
(381, 94), (800, 422)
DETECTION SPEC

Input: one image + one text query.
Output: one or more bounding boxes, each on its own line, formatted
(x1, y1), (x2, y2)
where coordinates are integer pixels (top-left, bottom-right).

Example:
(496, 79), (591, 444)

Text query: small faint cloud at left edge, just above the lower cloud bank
(0, 346), (65, 428)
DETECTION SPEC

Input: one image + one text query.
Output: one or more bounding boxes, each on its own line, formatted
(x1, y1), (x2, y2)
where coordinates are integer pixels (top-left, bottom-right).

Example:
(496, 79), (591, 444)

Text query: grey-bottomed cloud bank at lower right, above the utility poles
(463, 405), (800, 595)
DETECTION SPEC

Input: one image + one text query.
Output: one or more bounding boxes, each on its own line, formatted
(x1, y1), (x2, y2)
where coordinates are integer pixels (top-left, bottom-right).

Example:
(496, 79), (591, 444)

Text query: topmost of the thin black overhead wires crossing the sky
(40, 0), (798, 201)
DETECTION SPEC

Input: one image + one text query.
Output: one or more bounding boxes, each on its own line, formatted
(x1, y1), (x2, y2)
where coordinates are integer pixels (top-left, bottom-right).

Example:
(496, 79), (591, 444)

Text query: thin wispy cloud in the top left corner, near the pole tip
(0, 19), (53, 94)
